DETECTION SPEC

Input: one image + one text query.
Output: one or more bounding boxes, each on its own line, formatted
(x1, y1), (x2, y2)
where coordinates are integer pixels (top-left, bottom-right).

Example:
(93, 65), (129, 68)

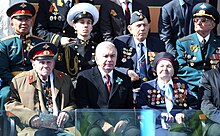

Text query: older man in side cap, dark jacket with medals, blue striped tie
(113, 11), (166, 88)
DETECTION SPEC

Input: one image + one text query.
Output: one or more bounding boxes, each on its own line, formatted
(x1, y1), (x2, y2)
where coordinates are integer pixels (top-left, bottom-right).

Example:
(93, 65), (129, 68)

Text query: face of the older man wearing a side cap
(128, 18), (150, 42)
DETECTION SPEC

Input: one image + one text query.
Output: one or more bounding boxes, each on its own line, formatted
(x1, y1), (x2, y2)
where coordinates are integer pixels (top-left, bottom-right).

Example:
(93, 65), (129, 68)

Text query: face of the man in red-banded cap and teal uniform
(11, 18), (33, 35)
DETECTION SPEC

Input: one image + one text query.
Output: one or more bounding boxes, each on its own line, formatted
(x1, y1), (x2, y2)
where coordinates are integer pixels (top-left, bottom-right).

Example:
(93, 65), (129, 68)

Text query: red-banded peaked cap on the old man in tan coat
(28, 42), (57, 60)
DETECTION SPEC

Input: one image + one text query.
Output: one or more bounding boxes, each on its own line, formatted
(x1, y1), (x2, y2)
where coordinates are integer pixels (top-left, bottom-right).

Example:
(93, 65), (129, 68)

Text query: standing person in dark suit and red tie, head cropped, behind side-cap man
(99, 0), (150, 41)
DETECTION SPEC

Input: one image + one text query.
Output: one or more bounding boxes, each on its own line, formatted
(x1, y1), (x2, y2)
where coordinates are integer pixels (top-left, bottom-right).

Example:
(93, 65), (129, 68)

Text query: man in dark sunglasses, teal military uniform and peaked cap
(176, 3), (220, 104)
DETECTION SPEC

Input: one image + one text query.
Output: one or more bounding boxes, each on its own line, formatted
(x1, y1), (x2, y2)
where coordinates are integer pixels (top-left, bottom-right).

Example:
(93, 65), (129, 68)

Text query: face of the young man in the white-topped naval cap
(73, 18), (93, 37)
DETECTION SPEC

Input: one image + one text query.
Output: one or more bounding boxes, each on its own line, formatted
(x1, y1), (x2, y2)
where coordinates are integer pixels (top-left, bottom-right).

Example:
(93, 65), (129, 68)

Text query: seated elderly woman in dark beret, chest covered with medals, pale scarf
(137, 52), (199, 136)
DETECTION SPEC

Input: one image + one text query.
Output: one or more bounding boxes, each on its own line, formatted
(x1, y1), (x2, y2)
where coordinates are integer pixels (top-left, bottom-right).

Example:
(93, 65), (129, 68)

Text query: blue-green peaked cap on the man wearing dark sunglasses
(192, 2), (219, 24)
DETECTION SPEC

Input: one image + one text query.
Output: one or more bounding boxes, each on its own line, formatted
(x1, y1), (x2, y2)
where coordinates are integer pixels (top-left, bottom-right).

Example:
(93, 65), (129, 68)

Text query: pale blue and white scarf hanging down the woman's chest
(165, 84), (174, 113)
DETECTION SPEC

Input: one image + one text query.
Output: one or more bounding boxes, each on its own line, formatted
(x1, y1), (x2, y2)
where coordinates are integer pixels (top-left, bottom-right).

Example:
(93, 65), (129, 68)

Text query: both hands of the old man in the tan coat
(31, 112), (70, 128)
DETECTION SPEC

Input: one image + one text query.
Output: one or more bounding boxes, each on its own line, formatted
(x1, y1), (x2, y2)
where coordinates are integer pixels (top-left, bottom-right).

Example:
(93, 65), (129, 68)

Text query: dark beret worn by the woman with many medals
(154, 52), (179, 75)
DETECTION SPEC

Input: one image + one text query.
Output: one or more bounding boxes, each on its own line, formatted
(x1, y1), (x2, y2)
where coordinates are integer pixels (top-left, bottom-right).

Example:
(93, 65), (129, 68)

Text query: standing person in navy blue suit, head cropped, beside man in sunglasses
(158, 0), (205, 53)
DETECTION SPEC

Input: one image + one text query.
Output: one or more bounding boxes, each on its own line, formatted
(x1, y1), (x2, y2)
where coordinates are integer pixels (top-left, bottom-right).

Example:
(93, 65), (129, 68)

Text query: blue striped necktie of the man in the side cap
(138, 43), (147, 82)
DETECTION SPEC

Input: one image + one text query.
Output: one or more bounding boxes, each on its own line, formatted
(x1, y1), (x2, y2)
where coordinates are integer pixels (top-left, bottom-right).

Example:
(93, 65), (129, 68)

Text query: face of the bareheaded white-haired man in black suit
(95, 47), (117, 73)
